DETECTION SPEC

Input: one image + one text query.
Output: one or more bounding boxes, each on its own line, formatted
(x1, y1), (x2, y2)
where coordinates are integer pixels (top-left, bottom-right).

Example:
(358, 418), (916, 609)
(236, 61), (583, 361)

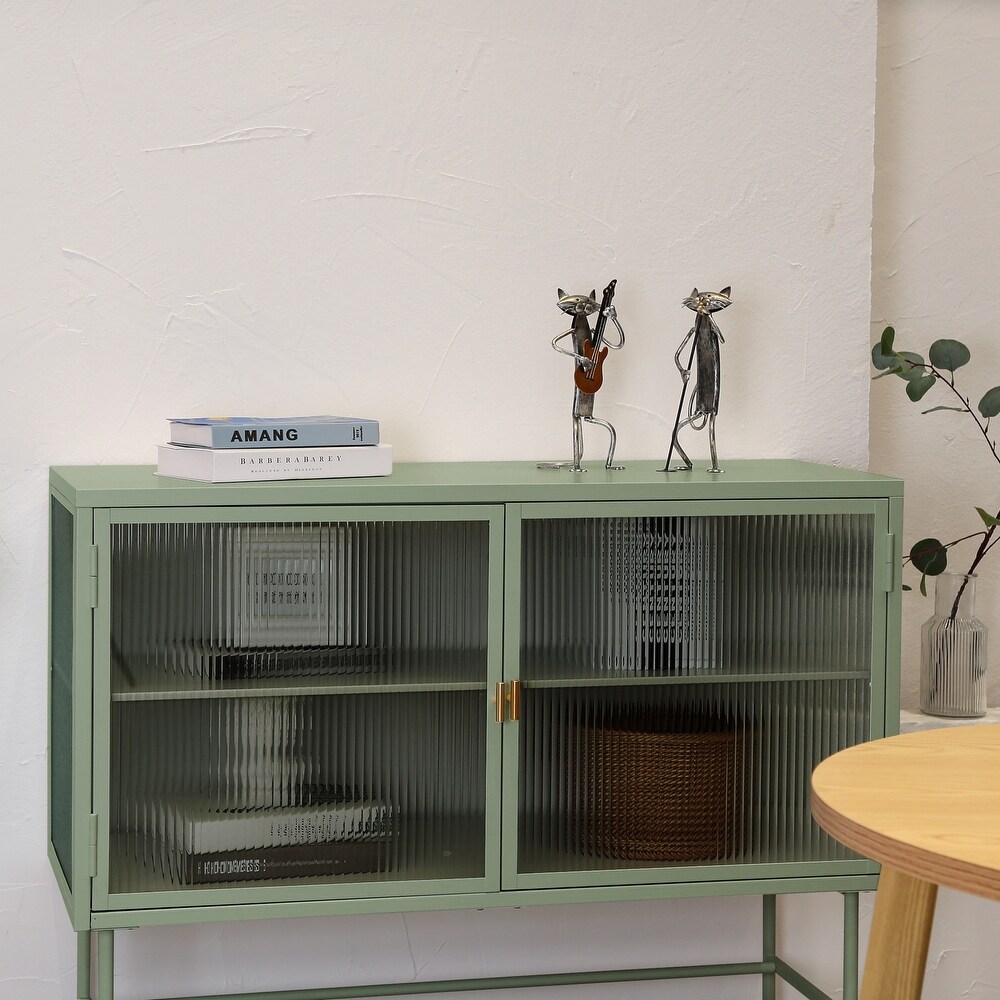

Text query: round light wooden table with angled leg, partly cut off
(812, 725), (1000, 1000)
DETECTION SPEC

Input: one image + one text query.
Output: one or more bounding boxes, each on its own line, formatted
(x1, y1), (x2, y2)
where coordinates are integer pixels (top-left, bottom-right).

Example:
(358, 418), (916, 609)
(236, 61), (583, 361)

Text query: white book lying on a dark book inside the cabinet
(164, 799), (392, 854)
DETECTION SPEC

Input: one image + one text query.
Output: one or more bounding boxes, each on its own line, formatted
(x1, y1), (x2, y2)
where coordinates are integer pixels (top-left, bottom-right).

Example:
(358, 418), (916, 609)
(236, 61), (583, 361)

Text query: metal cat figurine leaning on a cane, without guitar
(660, 285), (732, 472)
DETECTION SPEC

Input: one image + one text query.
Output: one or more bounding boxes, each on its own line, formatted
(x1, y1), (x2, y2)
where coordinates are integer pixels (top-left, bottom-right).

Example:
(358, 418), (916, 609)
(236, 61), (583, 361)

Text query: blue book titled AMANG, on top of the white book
(170, 416), (379, 448)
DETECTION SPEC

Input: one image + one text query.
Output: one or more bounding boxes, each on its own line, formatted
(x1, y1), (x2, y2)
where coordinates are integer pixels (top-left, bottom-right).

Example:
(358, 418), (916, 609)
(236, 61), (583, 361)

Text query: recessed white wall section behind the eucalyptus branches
(871, 0), (1000, 1000)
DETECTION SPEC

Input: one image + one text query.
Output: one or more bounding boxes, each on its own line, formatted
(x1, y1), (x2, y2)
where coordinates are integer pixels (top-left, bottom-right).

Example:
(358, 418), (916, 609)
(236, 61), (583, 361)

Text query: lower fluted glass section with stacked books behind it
(109, 691), (488, 892)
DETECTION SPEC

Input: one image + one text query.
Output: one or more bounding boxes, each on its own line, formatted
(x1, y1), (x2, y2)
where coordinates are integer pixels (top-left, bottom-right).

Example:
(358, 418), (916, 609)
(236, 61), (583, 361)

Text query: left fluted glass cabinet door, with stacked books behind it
(95, 507), (502, 903)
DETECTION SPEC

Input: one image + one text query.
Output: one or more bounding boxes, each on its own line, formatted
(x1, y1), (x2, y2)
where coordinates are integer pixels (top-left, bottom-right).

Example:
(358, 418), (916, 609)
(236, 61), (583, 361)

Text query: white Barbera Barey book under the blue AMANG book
(156, 444), (392, 483)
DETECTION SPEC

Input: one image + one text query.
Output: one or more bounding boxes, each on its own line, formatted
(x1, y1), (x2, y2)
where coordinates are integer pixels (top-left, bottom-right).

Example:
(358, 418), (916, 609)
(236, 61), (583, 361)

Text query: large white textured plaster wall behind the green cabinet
(0, 0), (876, 1000)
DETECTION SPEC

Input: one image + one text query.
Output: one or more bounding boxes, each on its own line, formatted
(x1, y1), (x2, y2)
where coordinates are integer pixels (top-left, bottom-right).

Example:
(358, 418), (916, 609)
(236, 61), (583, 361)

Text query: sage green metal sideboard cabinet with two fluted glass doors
(49, 461), (902, 1000)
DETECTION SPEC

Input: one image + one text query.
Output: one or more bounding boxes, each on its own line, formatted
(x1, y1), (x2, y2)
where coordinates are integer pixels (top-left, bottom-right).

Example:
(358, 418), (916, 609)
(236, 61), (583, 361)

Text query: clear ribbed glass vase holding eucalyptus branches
(920, 573), (987, 718)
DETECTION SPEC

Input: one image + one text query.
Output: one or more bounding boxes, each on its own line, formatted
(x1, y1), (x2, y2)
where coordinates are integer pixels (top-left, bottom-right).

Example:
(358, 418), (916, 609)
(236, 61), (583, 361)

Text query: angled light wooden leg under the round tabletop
(861, 865), (937, 1000)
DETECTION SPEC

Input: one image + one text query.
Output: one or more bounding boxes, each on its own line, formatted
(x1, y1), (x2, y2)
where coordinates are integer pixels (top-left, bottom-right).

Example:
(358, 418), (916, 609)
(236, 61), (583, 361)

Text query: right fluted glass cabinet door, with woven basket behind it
(508, 501), (885, 887)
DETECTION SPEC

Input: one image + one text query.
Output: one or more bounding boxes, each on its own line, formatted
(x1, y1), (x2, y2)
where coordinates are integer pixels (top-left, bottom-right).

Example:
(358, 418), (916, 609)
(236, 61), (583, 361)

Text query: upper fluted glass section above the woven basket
(521, 513), (874, 681)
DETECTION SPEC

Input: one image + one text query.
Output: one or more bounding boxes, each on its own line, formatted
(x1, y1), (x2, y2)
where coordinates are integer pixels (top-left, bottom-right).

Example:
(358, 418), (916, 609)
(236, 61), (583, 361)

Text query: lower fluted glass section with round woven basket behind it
(518, 678), (869, 873)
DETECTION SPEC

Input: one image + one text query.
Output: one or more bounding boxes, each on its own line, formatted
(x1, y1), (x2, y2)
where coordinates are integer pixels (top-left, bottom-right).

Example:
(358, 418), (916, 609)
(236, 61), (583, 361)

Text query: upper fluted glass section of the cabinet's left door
(111, 521), (489, 697)
